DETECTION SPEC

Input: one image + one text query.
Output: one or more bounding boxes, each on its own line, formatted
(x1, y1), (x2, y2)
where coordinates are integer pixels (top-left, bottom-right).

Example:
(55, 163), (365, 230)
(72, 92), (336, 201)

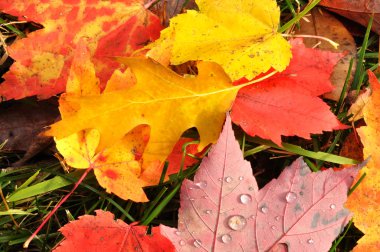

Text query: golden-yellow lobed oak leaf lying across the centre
(49, 58), (242, 166)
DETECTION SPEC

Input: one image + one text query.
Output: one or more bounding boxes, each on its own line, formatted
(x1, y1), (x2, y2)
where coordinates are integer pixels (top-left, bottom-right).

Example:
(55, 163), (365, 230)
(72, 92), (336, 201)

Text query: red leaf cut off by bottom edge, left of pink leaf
(53, 210), (175, 252)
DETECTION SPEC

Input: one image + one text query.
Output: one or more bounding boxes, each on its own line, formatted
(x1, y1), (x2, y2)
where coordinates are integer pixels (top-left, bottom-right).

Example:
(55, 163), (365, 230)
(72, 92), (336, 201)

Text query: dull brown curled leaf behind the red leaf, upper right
(296, 8), (356, 101)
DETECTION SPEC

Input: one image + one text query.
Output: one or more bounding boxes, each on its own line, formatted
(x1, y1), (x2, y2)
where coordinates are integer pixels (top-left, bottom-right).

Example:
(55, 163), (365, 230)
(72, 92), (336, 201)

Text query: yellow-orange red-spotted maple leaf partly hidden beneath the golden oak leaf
(55, 40), (153, 202)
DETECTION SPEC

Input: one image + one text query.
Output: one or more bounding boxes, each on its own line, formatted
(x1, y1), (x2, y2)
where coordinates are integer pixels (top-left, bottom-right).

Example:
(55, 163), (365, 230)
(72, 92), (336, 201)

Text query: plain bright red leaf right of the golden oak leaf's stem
(232, 39), (345, 145)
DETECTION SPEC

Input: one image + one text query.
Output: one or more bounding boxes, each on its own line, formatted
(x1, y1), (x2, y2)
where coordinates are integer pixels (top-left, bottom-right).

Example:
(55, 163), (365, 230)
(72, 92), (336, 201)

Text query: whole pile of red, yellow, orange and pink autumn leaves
(0, 0), (380, 251)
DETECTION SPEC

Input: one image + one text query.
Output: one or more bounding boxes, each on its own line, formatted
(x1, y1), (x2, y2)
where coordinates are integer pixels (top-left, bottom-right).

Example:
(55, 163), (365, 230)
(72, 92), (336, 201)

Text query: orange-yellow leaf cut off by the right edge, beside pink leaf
(347, 71), (380, 252)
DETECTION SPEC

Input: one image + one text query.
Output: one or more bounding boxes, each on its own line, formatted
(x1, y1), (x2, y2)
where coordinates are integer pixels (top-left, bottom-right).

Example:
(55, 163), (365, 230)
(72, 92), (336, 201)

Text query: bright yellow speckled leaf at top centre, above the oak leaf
(147, 0), (291, 80)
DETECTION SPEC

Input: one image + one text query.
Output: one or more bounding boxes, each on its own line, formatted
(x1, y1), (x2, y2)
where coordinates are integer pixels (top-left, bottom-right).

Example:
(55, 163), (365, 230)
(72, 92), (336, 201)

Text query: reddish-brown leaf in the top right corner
(319, 0), (380, 34)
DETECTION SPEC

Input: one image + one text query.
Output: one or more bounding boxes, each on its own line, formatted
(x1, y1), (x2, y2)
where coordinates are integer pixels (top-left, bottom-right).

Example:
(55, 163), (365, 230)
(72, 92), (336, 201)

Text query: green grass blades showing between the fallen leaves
(0, 0), (378, 252)
